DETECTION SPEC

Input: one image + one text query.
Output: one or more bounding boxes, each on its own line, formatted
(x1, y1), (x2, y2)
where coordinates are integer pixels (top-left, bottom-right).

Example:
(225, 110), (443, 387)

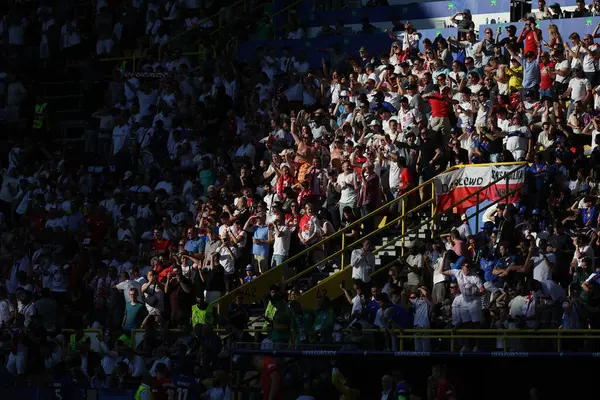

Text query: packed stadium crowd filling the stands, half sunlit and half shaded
(0, 0), (600, 399)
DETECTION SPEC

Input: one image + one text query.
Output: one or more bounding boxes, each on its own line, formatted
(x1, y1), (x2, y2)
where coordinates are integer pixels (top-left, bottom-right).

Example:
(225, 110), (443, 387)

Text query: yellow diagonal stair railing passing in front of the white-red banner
(298, 162), (527, 309)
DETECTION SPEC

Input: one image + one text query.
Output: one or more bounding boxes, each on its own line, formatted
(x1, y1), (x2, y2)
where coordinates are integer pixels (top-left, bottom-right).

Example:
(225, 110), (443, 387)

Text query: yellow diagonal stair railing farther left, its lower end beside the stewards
(212, 163), (522, 316)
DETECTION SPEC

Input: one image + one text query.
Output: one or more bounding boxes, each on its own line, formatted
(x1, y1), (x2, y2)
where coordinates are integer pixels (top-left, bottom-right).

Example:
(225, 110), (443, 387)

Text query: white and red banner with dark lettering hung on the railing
(434, 165), (525, 212)
